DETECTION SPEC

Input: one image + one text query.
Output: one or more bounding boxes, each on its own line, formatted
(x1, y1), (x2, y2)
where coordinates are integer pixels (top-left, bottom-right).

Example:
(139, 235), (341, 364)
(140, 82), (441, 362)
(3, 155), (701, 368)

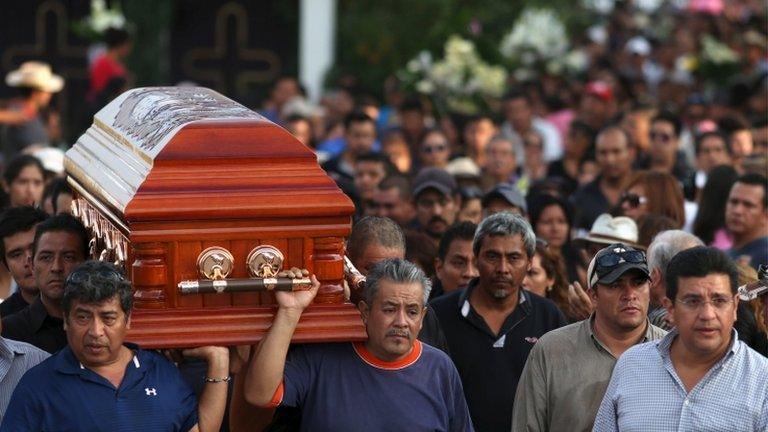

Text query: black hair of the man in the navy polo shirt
(61, 260), (133, 319)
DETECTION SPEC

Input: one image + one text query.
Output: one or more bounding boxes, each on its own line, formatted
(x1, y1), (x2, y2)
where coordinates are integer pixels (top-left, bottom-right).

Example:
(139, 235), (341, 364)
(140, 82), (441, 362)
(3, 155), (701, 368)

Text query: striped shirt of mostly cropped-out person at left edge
(0, 337), (50, 422)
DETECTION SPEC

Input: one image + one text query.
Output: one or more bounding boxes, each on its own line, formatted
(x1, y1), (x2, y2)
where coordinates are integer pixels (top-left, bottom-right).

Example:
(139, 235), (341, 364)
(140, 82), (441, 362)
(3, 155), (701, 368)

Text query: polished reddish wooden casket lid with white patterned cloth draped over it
(64, 87), (354, 222)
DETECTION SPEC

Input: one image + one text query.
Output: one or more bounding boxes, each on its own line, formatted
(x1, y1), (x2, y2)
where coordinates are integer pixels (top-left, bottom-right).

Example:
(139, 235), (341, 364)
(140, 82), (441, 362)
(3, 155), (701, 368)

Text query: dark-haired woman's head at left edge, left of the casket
(3, 155), (45, 207)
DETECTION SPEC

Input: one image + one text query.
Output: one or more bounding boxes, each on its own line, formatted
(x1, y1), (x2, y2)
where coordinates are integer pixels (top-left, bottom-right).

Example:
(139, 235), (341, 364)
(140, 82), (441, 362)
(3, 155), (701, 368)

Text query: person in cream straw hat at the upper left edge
(3, 61), (64, 160)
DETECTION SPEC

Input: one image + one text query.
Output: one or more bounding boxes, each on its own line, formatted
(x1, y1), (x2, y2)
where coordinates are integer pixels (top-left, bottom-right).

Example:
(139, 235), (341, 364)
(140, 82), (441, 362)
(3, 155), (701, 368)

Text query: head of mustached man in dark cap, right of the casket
(412, 168), (461, 246)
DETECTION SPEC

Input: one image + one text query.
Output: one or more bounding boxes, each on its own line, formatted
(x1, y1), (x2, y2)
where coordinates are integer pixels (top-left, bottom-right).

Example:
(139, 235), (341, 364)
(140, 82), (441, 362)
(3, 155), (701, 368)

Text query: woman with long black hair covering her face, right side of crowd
(693, 165), (739, 250)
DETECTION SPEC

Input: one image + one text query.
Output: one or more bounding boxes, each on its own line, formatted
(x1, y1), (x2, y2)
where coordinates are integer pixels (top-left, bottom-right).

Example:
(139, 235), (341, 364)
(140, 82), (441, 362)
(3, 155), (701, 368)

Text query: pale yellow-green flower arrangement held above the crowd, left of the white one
(397, 35), (507, 114)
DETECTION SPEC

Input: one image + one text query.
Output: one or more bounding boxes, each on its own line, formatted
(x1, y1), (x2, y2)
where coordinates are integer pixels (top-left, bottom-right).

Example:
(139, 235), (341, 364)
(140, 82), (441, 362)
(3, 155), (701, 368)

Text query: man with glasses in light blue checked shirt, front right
(594, 246), (768, 432)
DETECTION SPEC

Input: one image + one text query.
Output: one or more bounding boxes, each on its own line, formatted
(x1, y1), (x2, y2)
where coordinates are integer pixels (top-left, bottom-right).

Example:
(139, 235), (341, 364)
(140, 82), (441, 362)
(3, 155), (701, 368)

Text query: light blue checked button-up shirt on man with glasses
(593, 329), (768, 432)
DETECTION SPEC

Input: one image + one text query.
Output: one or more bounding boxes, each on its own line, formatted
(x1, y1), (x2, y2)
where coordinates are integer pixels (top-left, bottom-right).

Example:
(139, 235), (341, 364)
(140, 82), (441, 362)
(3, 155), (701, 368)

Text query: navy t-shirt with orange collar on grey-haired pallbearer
(273, 341), (472, 432)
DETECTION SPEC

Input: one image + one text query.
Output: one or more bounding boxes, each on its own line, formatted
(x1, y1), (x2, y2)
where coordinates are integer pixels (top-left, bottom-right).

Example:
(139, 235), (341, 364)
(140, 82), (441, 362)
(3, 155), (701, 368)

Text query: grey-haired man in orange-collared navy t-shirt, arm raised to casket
(245, 259), (473, 432)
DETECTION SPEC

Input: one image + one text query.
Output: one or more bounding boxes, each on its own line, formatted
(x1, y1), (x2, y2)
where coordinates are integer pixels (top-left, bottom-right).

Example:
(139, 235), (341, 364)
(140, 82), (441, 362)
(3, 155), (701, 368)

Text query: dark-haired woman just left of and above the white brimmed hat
(528, 195), (579, 280)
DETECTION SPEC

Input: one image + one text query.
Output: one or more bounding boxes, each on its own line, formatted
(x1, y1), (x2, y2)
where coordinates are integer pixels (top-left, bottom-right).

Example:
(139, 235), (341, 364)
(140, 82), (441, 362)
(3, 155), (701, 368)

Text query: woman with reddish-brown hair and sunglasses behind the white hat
(619, 171), (685, 229)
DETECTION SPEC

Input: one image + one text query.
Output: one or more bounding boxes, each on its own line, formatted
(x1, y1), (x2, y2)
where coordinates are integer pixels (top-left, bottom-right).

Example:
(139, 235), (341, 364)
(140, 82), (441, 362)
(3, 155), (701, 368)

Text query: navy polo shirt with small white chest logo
(0, 344), (197, 432)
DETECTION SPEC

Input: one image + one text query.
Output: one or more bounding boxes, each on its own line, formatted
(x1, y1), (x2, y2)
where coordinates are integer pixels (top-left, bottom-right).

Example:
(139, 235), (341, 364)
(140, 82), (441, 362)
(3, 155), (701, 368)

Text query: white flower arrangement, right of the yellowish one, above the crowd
(499, 8), (587, 80)
